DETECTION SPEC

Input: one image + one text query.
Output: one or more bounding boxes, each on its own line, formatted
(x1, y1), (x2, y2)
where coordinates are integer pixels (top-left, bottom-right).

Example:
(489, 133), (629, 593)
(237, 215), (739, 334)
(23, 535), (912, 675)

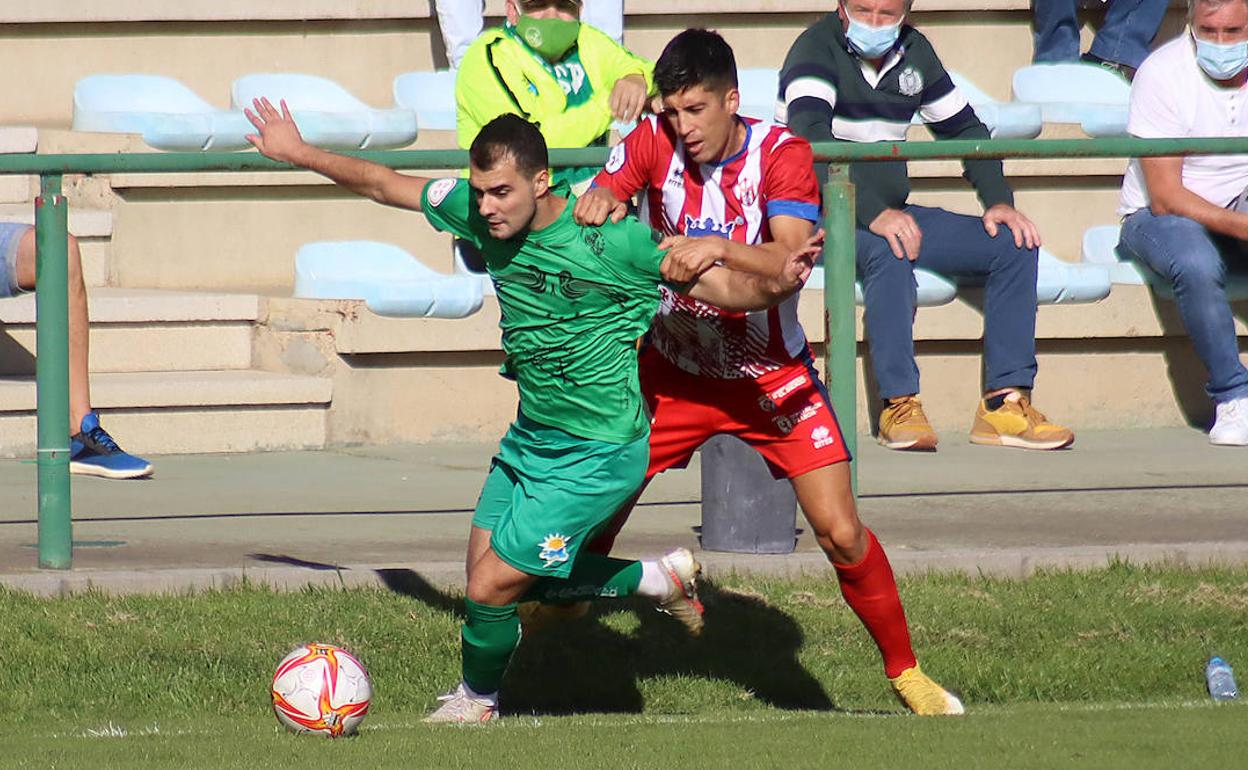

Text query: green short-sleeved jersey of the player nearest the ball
(421, 178), (663, 443)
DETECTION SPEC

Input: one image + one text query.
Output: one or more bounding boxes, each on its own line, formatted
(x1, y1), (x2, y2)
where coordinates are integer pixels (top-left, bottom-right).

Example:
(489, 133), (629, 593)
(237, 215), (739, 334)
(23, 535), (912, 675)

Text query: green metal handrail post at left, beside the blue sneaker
(35, 173), (74, 569)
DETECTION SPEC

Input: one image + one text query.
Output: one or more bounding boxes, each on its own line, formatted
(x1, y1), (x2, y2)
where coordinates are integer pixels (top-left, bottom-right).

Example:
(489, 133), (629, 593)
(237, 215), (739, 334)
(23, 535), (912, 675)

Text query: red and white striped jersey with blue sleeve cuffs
(594, 116), (819, 379)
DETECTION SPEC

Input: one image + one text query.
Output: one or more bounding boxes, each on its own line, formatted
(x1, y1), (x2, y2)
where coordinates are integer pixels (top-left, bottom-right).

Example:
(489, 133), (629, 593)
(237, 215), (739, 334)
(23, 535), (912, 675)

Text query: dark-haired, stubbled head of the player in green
(468, 115), (550, 240)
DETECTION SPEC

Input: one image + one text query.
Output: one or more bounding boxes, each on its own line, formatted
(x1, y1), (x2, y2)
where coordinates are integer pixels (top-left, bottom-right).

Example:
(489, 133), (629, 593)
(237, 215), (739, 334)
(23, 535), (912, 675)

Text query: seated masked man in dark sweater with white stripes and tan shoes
(776, 0), (1075, 451)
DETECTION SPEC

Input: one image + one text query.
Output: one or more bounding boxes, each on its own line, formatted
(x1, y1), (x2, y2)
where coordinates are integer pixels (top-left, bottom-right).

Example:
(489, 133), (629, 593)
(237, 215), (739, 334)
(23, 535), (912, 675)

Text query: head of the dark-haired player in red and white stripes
(654, 30), (741, 163)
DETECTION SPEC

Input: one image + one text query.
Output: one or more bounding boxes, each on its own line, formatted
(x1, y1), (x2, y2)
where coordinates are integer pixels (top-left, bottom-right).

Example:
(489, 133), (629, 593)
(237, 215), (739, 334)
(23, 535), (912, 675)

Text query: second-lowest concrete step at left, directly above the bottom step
(0, 288), (263, 376)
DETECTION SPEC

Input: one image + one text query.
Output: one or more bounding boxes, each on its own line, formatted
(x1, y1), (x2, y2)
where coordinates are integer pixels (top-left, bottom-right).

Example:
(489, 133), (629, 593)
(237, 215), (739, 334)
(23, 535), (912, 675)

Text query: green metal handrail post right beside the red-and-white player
(824, 163), (857, 498)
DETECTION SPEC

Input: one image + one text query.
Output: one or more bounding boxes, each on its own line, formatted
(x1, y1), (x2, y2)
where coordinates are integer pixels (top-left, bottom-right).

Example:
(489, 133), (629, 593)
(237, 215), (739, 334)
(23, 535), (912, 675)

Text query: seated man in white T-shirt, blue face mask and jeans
(1118, 0), (1248, 447)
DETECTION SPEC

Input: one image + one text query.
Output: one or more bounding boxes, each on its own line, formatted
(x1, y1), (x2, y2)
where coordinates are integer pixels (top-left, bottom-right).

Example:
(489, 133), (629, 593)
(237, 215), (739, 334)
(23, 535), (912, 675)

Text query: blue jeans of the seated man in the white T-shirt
(1118, 208), (1248, 403)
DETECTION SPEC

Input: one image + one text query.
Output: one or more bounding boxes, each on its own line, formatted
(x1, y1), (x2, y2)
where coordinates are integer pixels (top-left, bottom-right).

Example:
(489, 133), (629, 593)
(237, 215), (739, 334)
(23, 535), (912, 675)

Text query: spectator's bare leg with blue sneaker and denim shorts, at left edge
(0, 222), (152, 478)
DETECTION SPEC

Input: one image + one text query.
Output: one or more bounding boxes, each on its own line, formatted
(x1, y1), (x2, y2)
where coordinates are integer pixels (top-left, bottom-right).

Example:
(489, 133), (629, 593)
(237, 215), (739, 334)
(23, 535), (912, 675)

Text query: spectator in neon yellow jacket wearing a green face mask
(456, 0), (654, 186)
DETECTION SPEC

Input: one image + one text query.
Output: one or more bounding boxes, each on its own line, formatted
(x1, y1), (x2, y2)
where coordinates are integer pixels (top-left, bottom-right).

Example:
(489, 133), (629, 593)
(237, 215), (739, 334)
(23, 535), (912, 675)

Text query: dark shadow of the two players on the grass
(377, 569), (839, 715)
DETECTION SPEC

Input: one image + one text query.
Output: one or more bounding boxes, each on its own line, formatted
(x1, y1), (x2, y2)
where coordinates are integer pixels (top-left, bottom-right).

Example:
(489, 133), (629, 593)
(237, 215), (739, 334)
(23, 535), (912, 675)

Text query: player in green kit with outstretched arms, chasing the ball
(247, 100), (821, 723)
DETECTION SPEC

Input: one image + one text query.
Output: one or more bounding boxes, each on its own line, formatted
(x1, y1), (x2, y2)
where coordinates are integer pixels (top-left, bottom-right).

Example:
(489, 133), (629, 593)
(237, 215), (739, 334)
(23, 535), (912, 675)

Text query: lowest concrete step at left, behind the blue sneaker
(0, 371), (333, 457)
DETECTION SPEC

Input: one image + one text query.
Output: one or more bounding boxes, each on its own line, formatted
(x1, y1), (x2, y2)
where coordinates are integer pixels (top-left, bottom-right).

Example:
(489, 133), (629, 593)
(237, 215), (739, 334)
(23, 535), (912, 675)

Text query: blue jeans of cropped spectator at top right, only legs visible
(1031, 0), (1169, 69)
